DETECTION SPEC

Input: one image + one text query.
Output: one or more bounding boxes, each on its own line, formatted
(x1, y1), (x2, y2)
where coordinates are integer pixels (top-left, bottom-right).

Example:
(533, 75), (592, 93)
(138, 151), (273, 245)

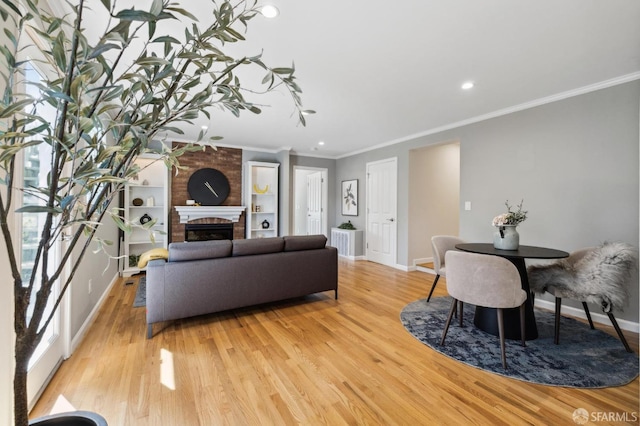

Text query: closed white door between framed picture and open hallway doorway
(365, 158), (398, 267)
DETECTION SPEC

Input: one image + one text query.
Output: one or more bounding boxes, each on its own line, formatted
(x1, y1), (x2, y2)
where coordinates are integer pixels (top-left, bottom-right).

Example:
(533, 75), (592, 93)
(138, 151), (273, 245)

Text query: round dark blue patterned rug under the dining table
(400, 297), (639, 388)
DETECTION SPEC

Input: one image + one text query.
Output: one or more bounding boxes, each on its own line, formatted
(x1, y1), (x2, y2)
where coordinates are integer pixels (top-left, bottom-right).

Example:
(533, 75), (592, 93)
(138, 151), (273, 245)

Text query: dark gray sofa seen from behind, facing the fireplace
(146, 235), (338, 338)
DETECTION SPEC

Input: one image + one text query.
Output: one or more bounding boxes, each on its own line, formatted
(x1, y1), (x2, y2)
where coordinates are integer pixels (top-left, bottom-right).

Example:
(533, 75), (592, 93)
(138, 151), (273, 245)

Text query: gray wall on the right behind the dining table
(335, 80), (640, 323)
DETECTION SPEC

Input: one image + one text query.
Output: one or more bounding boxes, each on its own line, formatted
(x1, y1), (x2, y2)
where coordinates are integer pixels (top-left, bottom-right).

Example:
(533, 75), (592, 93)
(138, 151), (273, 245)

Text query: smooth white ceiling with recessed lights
(84, 0), (640, 158)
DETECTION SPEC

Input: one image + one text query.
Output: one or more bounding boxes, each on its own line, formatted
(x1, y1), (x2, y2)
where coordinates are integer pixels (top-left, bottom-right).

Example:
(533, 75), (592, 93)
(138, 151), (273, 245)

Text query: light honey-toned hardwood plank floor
(32, 259), (639, 426)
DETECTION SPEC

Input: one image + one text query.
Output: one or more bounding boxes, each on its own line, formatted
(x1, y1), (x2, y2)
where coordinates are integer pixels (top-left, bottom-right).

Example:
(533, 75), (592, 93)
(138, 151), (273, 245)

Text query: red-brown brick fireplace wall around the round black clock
(169, 143), (246, 242)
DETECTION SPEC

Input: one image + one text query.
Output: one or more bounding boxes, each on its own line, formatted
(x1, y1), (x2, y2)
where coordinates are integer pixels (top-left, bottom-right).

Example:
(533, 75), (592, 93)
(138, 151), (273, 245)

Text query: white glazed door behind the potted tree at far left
(16, 64), (68, 406)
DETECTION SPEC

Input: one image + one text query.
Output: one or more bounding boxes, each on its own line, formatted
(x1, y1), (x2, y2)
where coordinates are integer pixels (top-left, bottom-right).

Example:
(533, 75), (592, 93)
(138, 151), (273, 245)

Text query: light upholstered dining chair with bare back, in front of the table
(440, 251), (527, 369)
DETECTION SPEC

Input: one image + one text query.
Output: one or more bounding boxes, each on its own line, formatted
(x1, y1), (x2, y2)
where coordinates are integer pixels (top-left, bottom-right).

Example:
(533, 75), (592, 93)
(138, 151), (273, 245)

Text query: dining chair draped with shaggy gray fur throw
(527, 242), (638, 352)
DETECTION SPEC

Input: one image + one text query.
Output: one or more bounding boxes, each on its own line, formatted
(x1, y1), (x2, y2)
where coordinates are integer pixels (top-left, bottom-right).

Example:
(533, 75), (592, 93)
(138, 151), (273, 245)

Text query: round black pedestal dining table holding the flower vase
(456, 243), (569, 340)
